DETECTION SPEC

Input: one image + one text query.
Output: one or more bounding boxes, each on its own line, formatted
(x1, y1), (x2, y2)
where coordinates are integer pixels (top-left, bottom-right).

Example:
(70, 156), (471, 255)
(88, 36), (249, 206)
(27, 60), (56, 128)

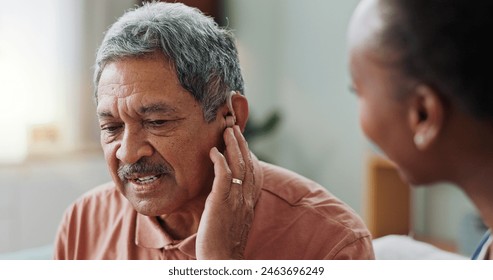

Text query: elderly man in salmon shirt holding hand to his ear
(55, 3), (373, 259)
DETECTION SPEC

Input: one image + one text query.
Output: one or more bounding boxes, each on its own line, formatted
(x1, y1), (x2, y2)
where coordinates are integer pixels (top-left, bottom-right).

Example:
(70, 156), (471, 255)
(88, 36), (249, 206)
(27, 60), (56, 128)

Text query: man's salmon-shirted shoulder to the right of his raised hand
(247, 162), (373, 259)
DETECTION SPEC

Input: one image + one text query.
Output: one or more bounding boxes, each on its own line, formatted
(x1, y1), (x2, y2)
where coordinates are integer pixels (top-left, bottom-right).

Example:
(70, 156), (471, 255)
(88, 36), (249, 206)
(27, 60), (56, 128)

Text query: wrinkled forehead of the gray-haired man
(97, 54), (196, 116)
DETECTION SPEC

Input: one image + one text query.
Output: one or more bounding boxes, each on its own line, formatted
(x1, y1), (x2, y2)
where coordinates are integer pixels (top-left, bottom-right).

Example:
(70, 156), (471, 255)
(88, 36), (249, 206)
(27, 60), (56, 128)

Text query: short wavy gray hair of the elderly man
(94, 2), (244, 122)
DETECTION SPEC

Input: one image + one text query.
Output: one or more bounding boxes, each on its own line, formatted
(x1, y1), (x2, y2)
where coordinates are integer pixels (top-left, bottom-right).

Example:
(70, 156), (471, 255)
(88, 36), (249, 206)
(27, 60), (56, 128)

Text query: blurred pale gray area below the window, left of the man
(0, 154), (110, 253)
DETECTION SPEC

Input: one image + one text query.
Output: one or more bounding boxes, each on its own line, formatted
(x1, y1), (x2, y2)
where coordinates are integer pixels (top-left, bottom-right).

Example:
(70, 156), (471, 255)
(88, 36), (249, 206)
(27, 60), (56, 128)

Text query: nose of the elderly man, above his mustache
(116, 130), (154, 164)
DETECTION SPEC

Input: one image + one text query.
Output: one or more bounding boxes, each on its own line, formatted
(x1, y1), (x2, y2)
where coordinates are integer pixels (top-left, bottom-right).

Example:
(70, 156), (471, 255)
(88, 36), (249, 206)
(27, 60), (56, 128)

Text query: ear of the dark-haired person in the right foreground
(409, 84), (445, 151)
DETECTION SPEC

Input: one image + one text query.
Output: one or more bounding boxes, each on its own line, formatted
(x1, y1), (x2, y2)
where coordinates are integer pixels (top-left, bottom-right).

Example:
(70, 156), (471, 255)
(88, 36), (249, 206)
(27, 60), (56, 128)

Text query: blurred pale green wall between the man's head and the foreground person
(225, 0), (366, 214)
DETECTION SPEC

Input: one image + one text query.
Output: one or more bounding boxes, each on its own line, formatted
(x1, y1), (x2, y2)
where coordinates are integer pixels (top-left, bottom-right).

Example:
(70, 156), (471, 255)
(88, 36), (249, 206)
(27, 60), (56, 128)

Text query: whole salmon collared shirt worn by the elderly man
(54, 162), (374, 260)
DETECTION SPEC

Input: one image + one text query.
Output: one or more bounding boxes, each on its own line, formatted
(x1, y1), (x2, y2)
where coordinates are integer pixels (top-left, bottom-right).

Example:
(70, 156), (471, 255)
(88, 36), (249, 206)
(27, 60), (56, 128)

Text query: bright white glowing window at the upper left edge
(0, 0), (68, 163)
